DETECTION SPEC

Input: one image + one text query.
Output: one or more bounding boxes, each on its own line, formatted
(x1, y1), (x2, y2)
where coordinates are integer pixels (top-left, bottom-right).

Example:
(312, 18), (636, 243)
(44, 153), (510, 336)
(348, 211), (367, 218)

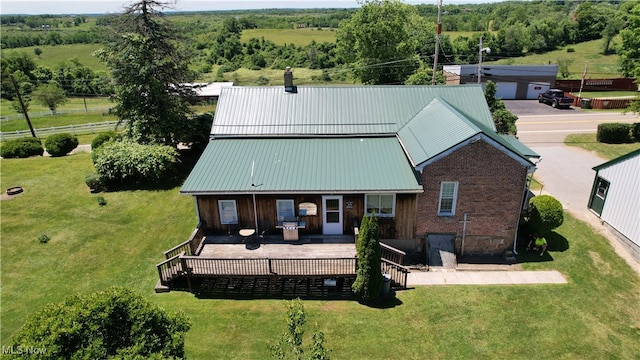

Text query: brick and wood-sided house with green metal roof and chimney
(180, 73), (537, 254)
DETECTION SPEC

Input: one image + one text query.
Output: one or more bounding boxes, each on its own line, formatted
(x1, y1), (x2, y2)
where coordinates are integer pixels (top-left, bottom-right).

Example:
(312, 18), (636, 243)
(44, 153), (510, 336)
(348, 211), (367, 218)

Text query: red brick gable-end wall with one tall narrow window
(416, 141), (527, 254)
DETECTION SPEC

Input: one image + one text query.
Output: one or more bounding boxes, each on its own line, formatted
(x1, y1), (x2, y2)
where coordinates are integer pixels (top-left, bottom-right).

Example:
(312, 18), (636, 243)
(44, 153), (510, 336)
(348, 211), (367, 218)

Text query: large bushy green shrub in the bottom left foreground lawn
(9, 287), (191, 359)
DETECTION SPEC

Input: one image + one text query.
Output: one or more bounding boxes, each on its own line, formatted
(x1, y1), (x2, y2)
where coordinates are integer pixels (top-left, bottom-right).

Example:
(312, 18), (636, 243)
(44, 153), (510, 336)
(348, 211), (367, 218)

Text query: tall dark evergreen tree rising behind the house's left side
(98, 0), (195, 145)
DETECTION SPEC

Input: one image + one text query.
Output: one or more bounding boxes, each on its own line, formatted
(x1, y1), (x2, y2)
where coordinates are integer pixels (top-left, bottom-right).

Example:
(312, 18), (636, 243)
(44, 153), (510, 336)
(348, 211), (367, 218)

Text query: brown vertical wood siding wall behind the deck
(197, 194), (417, 239)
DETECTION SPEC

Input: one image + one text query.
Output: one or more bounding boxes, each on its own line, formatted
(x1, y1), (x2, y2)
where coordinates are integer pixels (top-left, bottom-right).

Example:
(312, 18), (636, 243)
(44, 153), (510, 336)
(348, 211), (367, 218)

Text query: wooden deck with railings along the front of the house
(156, 229), (407, 291)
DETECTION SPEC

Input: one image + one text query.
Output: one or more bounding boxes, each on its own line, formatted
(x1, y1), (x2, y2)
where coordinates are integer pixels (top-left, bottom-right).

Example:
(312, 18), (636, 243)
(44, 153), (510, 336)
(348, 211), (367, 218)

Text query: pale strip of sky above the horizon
(0, 0), (500, 15)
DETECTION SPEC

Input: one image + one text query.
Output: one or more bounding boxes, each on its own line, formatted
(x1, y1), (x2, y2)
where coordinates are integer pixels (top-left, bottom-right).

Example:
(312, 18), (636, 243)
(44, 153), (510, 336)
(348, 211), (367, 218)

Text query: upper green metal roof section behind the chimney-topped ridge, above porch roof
(211, 84), (494, 137)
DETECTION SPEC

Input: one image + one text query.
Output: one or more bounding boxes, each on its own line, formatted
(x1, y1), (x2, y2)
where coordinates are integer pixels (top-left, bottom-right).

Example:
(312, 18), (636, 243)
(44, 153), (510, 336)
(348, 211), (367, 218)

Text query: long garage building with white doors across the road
(442, 63), (558, 100)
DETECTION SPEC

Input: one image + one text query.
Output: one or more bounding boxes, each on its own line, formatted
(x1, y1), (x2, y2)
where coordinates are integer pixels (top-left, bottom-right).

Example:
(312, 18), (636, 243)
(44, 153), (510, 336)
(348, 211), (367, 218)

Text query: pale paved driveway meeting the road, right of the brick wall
(505, 100), (640, 273)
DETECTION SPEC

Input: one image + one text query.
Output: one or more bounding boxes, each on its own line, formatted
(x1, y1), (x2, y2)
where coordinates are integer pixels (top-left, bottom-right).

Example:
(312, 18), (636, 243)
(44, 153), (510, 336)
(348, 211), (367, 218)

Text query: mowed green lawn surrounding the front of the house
(0, 154), (640, 359)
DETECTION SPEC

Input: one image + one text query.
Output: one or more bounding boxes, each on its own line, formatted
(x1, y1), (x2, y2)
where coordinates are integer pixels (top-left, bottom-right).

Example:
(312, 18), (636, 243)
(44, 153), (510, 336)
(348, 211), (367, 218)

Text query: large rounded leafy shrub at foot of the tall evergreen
(91, 141), (178, 185)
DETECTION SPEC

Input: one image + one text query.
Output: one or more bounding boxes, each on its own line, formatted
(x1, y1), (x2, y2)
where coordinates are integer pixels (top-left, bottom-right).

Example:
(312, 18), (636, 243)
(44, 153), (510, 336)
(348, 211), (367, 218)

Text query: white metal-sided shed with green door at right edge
(589, 150), (640, 261)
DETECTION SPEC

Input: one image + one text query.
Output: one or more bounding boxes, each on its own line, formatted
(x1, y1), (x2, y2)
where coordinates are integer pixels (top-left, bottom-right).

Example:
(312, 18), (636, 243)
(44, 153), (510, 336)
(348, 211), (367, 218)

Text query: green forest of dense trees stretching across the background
(0, 0), (638, 99)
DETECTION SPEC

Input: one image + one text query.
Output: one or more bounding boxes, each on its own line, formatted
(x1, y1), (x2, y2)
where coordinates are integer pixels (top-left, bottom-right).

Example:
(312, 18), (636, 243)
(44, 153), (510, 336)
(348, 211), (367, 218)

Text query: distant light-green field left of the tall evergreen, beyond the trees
(2, 44), (107, 71)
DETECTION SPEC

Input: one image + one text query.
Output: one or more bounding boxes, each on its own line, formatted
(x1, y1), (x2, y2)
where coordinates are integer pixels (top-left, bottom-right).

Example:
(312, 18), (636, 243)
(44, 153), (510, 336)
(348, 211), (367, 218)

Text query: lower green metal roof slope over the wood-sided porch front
(180, 137), (422, 194)
